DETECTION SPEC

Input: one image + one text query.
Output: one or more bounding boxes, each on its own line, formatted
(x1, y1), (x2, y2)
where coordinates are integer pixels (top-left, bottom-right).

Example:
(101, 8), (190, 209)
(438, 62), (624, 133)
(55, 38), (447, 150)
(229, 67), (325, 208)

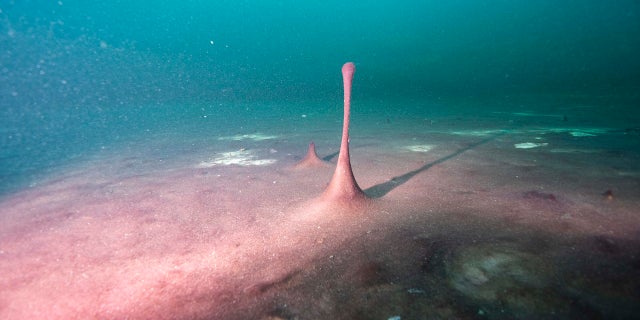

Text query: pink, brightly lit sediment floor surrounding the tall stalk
(0, 111), (640, 319)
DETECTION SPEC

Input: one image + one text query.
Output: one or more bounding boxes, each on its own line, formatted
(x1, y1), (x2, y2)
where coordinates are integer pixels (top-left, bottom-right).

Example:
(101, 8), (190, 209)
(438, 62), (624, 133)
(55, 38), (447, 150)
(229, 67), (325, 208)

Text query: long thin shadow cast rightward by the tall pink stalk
(364, 130), (507, 198)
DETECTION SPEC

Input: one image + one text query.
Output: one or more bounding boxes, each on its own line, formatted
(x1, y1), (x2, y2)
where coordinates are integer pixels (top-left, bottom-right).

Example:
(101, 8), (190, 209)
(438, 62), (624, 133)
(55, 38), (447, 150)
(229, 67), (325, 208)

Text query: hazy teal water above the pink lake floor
(0, 0), (640, 193)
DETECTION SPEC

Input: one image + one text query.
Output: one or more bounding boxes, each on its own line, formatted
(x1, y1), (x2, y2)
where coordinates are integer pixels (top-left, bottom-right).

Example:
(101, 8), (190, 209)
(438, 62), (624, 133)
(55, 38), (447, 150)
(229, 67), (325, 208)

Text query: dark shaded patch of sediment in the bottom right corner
(224, 209), (640, 320)
